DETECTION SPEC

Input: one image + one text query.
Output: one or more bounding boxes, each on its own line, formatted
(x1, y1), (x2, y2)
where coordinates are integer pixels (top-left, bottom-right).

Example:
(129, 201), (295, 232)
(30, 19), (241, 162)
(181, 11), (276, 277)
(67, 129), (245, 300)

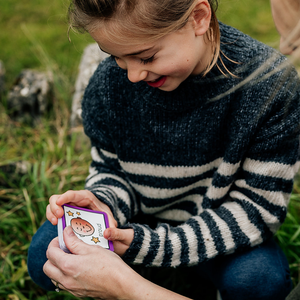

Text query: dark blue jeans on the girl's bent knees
(28, 221), (292, 300)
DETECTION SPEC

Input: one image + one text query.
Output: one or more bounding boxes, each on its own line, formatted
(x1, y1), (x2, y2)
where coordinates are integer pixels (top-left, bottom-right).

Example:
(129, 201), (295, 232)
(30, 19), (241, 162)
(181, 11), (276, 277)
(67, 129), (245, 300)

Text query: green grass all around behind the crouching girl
(0, 0), (300, 300)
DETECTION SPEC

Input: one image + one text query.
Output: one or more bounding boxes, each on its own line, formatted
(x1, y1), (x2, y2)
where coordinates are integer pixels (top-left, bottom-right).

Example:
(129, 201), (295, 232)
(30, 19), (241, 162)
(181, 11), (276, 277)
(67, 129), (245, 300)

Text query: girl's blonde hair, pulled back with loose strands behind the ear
(69, 0), (223, 75)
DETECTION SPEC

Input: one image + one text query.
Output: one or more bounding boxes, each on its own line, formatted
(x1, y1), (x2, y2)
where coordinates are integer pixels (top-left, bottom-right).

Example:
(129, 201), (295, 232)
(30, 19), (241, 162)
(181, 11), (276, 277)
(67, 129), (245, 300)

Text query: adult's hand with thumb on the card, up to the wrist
(44, 231), (132, 299)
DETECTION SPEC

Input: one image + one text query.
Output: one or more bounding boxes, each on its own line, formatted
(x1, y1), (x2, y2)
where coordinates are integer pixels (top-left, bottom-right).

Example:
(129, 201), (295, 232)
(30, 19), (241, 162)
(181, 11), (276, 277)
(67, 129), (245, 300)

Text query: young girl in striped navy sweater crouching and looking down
(28, 0), (300, 300)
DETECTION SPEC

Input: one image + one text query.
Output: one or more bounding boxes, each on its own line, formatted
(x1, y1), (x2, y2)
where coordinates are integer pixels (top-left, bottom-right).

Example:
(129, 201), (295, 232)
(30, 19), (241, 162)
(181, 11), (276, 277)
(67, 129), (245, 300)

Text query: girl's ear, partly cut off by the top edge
(191, 0), (211, 36)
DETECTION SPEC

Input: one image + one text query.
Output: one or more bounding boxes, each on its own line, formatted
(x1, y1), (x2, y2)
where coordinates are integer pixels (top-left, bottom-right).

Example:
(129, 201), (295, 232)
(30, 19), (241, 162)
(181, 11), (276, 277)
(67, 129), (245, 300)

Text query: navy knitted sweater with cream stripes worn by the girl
(82, 23), (300, 267)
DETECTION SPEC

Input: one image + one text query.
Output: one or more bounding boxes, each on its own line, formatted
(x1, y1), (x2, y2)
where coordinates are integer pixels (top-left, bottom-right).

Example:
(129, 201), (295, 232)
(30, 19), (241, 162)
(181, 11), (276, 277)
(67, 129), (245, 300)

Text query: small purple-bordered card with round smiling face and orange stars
(57, 204), (114, 253)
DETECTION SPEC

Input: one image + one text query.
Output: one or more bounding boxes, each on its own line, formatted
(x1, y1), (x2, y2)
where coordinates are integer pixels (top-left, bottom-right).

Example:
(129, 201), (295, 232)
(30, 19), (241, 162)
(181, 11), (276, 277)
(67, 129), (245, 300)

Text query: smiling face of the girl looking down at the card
(90, 22), (212, 91)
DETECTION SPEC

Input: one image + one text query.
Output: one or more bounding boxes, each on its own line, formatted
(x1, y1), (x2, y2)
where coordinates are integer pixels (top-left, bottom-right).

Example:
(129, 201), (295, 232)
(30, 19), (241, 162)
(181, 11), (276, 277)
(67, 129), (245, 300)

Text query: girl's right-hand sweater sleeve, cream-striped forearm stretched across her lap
(123, 61), (300, 267)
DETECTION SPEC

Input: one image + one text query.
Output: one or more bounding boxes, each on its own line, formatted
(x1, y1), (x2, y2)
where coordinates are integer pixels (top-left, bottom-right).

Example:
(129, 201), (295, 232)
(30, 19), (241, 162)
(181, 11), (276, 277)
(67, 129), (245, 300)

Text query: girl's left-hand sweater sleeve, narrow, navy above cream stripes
(82, 61), (138, 226)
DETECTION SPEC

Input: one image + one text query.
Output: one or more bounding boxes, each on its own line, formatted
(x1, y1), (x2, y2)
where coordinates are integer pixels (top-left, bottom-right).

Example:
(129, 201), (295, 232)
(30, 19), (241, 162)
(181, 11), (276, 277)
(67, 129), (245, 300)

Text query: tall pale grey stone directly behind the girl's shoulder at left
(71, 43), (109, 128)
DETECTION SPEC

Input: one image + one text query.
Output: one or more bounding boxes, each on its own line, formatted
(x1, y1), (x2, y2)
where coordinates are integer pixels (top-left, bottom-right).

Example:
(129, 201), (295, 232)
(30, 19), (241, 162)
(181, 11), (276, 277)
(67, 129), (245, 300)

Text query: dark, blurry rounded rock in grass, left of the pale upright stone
(7, 70), (54, 123)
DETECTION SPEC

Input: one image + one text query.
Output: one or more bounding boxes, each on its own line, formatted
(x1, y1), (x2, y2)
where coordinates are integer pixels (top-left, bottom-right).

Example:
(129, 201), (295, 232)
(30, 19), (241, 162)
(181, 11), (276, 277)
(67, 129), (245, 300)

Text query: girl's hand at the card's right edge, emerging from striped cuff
(103, 228), (134, 256)
